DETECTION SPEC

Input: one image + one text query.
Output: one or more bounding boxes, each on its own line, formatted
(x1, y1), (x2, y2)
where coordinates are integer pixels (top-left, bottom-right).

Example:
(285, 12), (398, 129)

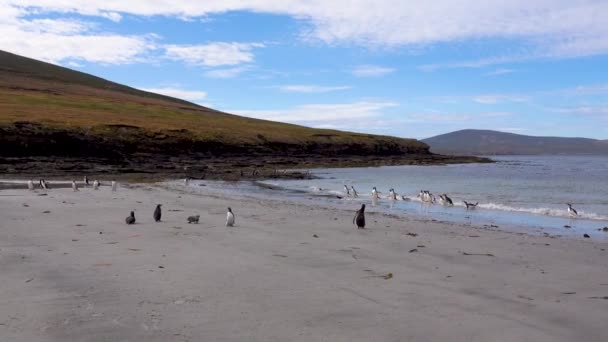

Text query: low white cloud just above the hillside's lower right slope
(229, 101), (399, 127)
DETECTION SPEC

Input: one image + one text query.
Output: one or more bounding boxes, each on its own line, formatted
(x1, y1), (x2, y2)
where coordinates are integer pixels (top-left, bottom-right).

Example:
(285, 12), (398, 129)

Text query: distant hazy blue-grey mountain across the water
(422, 129), (608, 155)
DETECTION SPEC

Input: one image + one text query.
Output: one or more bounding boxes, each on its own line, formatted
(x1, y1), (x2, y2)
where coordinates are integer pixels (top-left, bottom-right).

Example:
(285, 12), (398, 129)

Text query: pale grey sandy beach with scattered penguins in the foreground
(0, 180), (608, 342)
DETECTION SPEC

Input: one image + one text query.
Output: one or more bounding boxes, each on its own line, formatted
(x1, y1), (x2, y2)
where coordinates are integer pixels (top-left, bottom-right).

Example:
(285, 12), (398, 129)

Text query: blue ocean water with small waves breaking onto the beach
(190, 156), (608, 239)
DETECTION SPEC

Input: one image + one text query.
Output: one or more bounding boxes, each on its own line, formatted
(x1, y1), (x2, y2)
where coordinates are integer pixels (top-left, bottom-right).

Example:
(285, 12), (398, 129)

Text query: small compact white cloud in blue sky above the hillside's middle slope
(164, 42), (264, 67)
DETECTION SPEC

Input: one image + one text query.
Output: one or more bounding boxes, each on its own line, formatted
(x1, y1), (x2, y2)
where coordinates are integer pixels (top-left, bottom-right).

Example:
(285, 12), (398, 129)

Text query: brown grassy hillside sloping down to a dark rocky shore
(0, 51), (484, 179)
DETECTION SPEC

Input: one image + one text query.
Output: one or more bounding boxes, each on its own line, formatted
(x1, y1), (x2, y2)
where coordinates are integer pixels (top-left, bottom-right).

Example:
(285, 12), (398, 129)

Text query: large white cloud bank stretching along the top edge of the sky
(5, 0), (608, 57)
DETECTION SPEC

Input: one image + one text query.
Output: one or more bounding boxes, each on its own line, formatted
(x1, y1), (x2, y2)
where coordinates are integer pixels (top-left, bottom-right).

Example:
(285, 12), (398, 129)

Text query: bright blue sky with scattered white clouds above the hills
(0, 0), (608, 139)
